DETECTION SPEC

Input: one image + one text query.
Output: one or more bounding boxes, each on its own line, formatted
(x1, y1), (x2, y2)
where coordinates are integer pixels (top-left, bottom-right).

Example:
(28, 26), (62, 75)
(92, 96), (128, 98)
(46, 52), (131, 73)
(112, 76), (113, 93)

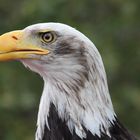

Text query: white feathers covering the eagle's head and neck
(22, 23), (115, 140)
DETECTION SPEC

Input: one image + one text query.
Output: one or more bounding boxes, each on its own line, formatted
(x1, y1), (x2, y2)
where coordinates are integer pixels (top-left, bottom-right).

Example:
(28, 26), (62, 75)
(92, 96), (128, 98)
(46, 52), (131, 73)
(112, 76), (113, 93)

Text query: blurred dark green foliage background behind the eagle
(0, 0), (140, 140)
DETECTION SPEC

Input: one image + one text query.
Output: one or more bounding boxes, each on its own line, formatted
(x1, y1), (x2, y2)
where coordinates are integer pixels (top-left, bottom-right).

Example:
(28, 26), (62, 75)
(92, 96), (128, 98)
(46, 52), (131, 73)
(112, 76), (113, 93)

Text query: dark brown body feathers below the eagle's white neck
(43, 104), (138, 140)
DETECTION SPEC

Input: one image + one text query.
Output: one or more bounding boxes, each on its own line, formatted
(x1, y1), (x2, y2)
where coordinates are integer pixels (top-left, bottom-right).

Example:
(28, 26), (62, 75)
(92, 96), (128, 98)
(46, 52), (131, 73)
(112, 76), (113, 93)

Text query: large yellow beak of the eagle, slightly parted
(0, 30), (49, 61)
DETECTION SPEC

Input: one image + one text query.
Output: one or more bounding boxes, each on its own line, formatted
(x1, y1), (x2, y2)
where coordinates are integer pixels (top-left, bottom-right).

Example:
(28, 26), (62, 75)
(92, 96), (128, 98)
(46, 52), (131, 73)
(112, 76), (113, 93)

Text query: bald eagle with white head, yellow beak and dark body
(0, 23), (136, 140)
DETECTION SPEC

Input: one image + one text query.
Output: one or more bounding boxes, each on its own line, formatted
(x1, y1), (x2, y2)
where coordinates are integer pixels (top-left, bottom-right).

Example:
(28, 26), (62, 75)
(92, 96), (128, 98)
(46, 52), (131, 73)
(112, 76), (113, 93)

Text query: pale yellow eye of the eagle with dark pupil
(41, 32), (55, 43)
